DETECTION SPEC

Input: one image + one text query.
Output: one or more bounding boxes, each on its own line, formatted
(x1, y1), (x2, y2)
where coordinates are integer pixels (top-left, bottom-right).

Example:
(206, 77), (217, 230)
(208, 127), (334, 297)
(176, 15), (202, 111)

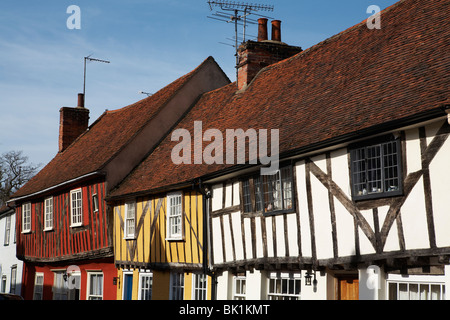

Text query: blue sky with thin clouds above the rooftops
(0, 0), (397, 165)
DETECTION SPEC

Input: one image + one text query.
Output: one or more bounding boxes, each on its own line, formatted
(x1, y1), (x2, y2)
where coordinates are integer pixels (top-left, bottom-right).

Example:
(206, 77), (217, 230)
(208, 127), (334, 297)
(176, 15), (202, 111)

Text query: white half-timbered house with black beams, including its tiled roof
(207, 0), (450, 300)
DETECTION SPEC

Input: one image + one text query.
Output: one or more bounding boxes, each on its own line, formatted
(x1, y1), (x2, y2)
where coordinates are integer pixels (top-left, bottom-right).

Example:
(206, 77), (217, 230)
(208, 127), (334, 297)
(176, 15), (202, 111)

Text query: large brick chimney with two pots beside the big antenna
(237, 18), (302, 90)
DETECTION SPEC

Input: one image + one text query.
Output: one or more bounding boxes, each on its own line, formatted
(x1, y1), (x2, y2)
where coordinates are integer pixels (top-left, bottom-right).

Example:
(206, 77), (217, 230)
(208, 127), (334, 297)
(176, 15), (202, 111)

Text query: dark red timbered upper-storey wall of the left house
(16, 181), (113, 259)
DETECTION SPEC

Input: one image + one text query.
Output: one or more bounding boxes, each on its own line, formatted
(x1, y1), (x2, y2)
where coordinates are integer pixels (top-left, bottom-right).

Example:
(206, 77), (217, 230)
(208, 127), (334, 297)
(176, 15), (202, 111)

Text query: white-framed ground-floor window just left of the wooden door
(267, 273), (301, 300)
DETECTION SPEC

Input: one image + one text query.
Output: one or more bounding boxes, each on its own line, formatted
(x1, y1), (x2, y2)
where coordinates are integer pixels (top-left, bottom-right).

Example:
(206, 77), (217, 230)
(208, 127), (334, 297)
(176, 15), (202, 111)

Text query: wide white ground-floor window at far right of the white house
(387, 275), (445, 300)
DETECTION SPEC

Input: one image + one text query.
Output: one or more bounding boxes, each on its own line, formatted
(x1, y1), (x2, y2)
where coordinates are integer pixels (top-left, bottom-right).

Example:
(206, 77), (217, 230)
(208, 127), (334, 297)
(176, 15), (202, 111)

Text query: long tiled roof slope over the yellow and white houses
(111, 0), (450, 197)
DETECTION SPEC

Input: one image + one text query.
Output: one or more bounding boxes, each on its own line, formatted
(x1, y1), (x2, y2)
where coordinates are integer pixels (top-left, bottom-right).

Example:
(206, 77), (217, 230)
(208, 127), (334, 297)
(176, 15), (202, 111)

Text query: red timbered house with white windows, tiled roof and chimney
(9, 58), (229, 300)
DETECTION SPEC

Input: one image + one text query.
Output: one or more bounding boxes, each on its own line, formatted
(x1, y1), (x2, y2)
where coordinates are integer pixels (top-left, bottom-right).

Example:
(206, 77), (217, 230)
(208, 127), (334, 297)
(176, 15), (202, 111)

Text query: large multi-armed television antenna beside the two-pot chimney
(207, 0), (274, 79)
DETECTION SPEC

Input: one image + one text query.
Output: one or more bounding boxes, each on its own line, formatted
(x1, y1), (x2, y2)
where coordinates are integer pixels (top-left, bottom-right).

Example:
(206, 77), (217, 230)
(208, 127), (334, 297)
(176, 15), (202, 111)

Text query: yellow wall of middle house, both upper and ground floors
(114, 191), (211, 300)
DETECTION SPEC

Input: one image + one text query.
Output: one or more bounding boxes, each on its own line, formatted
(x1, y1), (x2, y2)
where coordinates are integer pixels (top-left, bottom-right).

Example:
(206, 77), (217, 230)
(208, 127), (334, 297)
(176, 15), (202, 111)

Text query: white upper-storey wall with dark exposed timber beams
(210, 121), (450, 273)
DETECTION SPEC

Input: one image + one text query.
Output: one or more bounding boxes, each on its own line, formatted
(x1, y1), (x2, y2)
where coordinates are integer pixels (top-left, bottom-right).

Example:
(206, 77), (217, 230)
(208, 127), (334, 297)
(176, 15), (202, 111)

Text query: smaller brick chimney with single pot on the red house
(59, 93), (89, 152)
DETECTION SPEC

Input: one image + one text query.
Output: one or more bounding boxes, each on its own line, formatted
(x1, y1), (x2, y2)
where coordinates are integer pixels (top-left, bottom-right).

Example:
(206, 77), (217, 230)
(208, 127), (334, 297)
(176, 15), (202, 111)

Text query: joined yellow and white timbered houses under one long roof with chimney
(107, 0), (450, 299)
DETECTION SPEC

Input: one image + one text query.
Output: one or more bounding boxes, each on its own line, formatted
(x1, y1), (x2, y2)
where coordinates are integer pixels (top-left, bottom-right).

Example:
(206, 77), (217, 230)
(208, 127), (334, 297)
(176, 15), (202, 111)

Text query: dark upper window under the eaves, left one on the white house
(242, 166), (294, 214)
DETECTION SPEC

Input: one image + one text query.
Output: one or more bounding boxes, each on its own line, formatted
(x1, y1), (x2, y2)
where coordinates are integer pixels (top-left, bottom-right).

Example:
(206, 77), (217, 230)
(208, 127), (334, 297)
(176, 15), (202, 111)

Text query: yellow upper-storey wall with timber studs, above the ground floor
(114, 192), (203, 264)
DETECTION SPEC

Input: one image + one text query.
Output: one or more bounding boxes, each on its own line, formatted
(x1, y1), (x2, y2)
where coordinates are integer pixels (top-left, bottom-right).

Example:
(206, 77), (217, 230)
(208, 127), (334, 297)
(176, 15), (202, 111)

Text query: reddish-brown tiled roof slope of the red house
(12, 57), (220, 198)
